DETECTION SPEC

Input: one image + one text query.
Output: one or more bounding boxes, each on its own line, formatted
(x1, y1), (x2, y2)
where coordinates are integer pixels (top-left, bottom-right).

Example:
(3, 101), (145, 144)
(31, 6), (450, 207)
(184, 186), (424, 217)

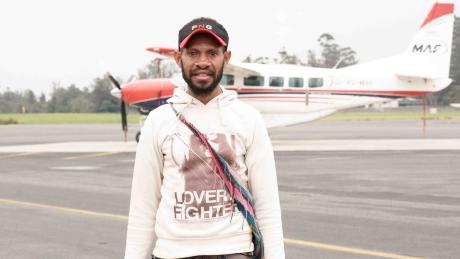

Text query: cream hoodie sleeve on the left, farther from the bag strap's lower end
(125, 115), (163, 259)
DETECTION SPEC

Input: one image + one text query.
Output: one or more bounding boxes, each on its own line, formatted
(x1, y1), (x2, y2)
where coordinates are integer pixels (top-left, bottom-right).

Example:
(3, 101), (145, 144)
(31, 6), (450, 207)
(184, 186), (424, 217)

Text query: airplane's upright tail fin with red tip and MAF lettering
(398, 3), (454, 81)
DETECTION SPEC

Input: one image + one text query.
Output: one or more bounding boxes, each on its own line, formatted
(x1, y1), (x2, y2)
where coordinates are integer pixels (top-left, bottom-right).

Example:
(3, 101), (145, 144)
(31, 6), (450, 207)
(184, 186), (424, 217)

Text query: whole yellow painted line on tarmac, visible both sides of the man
(0, 199), (423, 259)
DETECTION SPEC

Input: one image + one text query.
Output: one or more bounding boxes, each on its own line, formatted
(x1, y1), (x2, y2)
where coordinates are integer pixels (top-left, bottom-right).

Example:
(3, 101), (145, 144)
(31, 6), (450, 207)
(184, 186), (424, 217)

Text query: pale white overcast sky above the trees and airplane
(0, 0), (460, 94)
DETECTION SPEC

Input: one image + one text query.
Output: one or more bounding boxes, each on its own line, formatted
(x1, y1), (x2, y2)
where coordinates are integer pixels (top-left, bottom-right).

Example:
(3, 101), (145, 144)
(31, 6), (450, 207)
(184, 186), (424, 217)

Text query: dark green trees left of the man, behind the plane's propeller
(0, 55), (178, 113)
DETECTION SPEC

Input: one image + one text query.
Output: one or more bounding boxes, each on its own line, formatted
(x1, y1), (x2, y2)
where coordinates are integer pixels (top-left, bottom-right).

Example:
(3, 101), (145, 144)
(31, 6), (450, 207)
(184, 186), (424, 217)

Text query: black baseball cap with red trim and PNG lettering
(179, 17), (228, 49)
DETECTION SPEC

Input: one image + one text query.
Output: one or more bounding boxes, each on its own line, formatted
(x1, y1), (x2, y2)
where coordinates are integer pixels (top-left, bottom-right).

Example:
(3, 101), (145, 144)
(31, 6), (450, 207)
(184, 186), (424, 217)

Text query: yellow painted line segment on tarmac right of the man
(284, 238), (422, 259)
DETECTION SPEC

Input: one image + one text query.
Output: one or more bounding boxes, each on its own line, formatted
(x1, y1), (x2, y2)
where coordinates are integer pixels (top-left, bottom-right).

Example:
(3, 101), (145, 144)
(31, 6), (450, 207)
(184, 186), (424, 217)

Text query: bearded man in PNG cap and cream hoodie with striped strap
(125, 18), (285, 259)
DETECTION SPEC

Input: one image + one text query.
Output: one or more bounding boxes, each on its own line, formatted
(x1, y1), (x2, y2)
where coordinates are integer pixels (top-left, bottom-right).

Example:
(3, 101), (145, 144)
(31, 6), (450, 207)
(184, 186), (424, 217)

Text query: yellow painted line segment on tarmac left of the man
(0, 199), (128, 221)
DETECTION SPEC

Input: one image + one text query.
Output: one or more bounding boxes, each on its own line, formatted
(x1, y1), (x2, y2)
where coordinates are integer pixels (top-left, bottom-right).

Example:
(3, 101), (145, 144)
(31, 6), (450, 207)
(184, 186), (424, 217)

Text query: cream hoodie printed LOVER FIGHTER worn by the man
(125, 88), (285, 259)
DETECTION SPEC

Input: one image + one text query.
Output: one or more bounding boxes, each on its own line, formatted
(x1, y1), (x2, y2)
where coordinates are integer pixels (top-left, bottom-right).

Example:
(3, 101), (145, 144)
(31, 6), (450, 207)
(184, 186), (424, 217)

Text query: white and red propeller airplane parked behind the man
(109, 3), (454, 140)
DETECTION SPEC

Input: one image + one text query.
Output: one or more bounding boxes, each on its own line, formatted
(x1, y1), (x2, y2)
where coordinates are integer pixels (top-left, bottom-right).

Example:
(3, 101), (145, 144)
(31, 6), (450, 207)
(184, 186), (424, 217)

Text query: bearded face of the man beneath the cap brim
(176, 33), (231, 96)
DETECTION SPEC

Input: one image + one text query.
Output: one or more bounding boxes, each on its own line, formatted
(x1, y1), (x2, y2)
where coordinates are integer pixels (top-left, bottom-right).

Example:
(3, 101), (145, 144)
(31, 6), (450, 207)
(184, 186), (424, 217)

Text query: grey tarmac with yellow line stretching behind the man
(0, 120), (460, 259)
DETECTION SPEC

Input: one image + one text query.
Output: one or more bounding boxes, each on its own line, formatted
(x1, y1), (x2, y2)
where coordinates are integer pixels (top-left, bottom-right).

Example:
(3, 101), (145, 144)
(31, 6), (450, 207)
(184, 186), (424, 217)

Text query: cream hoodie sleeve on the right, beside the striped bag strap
(246, 113), (285, 259)
